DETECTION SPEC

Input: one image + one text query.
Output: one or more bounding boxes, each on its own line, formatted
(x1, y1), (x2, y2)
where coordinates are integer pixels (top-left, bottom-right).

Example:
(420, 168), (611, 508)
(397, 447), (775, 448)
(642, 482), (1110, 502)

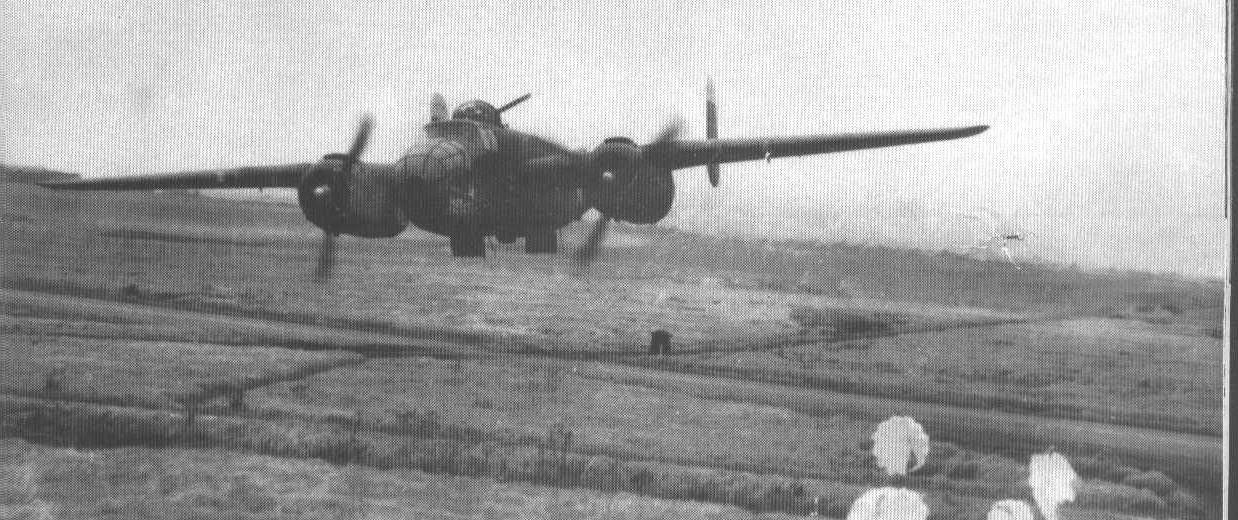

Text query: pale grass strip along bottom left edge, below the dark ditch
(0, 440), (777, 520)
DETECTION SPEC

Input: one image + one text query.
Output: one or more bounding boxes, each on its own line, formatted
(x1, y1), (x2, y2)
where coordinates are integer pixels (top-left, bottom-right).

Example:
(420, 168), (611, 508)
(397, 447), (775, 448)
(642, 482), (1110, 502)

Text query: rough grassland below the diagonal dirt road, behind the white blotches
(0, 359), (1198, 518)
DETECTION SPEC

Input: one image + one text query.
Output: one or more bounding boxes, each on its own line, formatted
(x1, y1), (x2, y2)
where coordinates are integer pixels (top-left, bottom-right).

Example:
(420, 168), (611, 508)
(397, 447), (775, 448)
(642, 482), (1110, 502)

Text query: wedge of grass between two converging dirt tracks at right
(633, 318), (1223, 436)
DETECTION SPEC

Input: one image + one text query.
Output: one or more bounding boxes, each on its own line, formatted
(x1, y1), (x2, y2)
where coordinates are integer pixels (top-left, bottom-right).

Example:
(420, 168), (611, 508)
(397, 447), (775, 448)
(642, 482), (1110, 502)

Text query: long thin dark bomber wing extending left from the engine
(38, 163), (313, 189)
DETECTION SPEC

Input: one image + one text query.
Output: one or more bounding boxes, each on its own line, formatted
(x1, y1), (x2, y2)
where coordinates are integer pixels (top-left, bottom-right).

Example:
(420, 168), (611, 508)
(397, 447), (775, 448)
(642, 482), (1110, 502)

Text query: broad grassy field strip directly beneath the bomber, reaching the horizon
(0, 183), (1222, 348)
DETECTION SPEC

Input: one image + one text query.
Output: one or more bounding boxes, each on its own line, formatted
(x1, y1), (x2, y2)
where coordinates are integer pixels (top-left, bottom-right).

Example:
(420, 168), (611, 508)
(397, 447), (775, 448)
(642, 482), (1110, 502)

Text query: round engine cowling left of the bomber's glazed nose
(297, 154), (406, 238)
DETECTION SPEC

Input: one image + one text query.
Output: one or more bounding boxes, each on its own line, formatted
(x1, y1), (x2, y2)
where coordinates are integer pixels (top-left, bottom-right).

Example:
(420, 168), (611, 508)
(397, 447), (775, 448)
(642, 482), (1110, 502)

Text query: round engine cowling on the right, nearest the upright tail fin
(591, 137), (675, 224)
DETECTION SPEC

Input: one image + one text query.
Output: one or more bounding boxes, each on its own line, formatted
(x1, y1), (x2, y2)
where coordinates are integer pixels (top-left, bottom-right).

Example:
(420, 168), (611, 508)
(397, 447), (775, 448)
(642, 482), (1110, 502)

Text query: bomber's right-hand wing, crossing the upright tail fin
(649, 125), (989, 168)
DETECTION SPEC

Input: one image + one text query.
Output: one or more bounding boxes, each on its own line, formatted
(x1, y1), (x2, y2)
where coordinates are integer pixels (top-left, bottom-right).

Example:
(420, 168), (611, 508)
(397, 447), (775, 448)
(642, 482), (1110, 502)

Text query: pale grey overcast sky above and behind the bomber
(0, 0), (1228, 275)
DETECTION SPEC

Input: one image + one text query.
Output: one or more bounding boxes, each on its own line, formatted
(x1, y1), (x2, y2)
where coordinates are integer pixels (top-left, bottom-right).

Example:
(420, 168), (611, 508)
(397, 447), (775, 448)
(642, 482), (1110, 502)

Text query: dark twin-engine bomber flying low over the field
(41, 83), (988, 279)
